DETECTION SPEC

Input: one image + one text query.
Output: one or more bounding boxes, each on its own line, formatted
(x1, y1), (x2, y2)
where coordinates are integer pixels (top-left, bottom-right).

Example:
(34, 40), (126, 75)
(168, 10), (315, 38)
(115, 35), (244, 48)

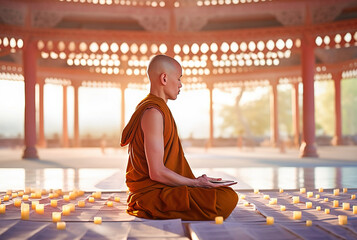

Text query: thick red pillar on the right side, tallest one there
(300, 33), (318, 157)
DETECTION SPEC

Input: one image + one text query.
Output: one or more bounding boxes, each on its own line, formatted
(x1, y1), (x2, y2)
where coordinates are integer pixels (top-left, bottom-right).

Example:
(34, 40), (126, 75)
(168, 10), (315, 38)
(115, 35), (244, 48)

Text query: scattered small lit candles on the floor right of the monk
(235, 188), (357, 226)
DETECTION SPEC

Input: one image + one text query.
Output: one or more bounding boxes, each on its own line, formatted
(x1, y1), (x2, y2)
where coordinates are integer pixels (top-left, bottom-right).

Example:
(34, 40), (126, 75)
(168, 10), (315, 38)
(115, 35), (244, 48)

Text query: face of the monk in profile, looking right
(165, 64), (182, 100)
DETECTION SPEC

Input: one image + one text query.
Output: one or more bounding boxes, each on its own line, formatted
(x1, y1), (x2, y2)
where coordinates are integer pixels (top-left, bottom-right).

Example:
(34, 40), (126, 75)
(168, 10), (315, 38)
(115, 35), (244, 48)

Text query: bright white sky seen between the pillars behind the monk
(0, 80), (267, 138)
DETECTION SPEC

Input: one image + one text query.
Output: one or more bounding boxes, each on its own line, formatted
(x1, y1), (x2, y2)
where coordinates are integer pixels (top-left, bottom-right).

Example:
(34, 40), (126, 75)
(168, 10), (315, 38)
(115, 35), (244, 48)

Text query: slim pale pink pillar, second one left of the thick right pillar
(270, 80), (279, 147)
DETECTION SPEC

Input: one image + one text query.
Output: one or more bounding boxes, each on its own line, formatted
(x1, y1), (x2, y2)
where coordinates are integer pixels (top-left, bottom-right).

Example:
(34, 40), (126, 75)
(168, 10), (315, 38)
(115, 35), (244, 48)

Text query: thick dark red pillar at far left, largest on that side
(22, 41), (38, 159)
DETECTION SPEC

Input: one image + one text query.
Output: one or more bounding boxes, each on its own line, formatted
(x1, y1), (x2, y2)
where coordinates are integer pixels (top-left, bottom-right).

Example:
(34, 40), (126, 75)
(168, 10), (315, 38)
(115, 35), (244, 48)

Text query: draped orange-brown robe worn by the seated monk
(121, 94), (238, 220)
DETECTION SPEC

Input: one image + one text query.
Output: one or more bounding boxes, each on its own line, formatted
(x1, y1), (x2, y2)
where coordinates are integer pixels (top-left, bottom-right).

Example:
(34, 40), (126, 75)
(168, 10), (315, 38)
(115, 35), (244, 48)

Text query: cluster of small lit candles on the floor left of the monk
(0, 189), (120, 230)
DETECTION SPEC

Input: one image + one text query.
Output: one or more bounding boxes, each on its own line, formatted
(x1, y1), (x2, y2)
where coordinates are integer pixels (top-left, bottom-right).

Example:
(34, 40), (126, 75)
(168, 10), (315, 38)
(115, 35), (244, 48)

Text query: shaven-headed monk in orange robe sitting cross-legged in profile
(121, 55), (238, 221)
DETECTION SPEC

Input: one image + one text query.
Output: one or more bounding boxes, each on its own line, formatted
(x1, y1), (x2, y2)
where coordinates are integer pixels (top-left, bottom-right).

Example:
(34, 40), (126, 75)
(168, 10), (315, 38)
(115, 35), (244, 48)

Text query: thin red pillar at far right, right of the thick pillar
(332, 72), (343, 146)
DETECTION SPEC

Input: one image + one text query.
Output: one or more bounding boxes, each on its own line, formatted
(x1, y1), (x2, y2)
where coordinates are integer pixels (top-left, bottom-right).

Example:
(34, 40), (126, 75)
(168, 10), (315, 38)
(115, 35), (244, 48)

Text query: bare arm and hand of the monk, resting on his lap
(141, 108), (219, 188)
